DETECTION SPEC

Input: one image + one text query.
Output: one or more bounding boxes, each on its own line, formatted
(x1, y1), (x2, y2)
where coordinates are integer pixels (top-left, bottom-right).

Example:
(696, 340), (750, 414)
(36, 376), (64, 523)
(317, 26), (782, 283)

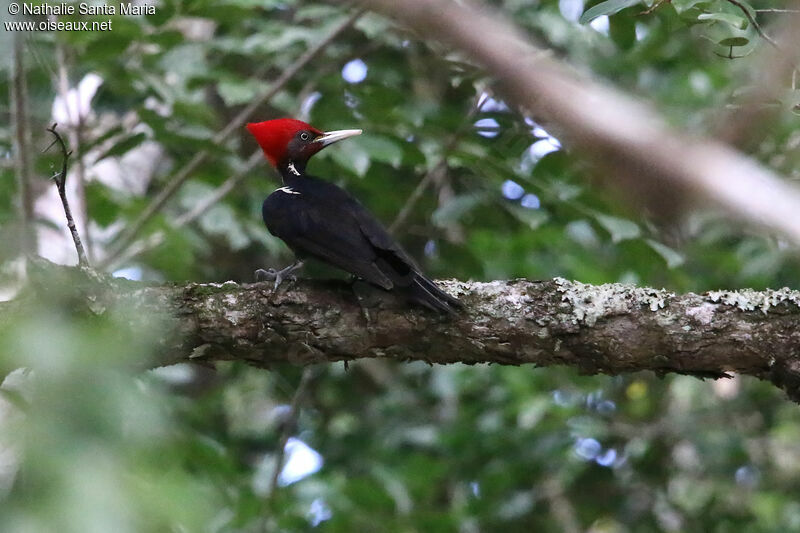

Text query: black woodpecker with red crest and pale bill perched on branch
(247, 118), (462, 313)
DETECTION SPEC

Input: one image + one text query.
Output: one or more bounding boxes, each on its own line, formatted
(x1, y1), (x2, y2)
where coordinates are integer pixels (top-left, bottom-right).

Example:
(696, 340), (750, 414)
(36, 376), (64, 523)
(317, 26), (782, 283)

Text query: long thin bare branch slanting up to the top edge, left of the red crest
(99, 10), (364, 269)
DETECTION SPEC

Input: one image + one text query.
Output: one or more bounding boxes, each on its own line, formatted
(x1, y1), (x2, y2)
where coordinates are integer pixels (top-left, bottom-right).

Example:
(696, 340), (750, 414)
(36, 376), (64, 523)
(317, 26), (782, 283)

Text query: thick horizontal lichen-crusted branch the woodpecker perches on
(6, 262), (800, 401)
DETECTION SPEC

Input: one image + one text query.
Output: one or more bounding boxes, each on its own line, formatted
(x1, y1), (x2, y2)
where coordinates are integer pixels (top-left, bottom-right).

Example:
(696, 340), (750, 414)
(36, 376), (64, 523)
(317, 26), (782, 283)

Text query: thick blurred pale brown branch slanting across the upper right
(363, 0), (800, 245)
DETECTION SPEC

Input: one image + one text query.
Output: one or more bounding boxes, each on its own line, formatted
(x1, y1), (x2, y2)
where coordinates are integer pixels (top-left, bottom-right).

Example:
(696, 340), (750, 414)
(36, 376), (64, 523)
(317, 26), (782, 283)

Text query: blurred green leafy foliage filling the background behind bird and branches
(0, 0), (800, 533)
